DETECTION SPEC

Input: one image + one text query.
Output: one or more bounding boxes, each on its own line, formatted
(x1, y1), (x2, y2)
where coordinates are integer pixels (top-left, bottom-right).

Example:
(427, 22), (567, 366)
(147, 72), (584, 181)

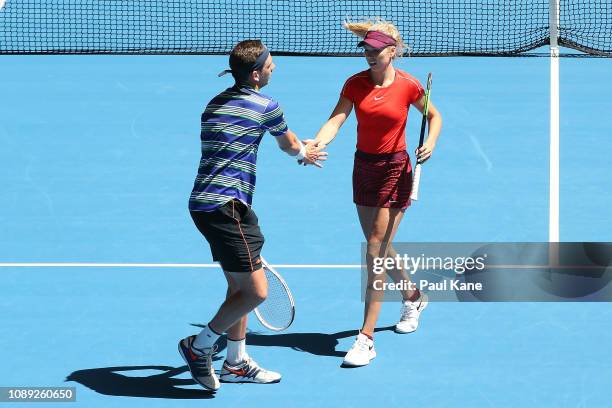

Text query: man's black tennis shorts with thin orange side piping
(190, 199), (264, 273)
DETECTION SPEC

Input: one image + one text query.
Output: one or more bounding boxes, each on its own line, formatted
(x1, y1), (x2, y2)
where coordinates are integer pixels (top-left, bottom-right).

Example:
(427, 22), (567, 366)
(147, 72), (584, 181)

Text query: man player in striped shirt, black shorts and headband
(178, 40), (327, 391)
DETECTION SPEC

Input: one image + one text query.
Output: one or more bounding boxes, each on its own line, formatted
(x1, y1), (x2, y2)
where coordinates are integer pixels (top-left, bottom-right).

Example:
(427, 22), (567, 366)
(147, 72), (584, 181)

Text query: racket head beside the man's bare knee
(254, 257), (295, 331)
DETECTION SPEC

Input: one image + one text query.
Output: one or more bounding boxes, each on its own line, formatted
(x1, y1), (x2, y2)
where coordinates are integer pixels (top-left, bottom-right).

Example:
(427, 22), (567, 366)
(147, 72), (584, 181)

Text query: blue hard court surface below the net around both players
(0, 48), (612, 407)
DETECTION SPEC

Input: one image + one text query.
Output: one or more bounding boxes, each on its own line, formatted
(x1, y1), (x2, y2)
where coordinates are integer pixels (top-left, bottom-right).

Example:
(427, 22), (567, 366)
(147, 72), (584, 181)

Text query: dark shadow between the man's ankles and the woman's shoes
(193, 324), (394, 357)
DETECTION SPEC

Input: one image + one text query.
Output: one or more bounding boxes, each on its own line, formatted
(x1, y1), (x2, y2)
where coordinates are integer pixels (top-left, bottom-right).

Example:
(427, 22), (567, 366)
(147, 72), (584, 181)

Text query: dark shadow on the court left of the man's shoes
(66, 366), (214, 399)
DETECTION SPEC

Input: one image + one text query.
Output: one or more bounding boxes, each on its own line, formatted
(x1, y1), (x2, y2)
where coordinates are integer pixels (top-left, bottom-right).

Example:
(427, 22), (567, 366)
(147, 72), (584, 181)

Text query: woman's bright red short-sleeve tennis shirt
(341, 69), (425, 154)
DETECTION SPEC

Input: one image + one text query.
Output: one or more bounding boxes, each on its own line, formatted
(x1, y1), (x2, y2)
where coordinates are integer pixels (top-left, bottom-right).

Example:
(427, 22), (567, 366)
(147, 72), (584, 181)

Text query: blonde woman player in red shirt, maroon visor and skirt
(315, 20), (442, 366)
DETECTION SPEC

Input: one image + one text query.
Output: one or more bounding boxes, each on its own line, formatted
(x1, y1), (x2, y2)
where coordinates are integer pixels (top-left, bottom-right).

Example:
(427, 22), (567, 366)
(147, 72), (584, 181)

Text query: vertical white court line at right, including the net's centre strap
(548, 0), (560, 265)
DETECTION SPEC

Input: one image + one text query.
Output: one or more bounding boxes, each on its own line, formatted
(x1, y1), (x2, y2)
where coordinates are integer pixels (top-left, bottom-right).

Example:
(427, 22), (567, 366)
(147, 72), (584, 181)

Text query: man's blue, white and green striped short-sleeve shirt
(189, 87), (288, 211)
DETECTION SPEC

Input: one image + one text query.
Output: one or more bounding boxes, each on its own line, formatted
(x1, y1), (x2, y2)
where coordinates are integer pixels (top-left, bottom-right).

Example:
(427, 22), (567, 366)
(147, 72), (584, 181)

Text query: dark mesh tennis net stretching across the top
(0, 0), (612, 56)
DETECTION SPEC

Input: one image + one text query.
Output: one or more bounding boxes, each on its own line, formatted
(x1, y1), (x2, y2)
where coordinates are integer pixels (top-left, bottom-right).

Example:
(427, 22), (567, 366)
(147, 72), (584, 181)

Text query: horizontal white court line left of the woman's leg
(0, 262), (361, 269)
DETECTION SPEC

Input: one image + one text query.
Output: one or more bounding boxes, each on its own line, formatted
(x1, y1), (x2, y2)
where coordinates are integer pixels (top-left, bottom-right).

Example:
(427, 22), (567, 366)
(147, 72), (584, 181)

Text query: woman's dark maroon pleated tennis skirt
(353, 150), (412, 210)
